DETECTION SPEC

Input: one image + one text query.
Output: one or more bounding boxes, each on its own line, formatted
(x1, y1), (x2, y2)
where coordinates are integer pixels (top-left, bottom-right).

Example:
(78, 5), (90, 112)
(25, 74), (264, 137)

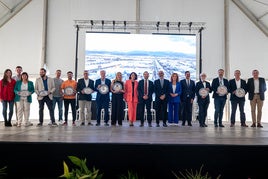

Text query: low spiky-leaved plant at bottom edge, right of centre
(172, 165), (221, 179)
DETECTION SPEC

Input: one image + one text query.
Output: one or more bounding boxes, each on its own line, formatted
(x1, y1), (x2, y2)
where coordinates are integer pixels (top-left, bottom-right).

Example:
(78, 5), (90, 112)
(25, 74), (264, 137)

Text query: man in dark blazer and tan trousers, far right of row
(247, 70), (266, 127)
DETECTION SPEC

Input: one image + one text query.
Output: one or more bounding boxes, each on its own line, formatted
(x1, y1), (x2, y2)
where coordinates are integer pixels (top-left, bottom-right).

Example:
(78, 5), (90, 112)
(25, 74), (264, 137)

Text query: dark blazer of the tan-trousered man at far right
(247, 78), (266, 100)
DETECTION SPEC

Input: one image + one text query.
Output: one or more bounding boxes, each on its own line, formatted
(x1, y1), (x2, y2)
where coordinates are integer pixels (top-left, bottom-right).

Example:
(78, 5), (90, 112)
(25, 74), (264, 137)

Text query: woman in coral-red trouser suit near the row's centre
(124, 72), (138, 127)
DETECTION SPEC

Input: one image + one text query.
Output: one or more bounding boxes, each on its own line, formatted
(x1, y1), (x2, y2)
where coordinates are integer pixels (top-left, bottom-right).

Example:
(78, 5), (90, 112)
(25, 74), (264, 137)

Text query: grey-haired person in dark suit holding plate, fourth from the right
(195, 73), (212, 127)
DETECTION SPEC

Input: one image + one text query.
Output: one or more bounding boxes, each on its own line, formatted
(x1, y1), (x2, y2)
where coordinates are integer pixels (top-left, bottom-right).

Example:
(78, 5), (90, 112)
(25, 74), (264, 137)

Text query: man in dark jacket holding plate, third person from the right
(212, 69), (229, 127)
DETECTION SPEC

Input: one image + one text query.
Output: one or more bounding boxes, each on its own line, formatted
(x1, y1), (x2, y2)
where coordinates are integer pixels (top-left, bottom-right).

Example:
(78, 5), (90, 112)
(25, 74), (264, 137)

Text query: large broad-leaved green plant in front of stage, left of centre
(60, 156), (102, 179)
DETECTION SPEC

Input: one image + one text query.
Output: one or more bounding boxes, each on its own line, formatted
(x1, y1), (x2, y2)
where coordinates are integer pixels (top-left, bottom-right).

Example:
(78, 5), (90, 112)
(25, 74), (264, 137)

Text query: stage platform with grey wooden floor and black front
(0, 121), (268, 179)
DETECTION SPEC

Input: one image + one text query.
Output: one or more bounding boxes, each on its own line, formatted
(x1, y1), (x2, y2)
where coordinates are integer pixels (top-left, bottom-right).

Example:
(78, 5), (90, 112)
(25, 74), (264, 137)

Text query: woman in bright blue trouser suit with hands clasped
(168, 73), (181, 125)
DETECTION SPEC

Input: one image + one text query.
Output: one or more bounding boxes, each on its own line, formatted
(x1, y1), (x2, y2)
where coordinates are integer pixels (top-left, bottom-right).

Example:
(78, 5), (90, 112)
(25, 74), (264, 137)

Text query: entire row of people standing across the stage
(0, 66), (266, 127)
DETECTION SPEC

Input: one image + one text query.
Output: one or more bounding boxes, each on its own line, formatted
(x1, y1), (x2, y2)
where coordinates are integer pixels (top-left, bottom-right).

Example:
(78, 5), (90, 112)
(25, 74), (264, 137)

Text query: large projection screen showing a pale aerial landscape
(85, 32), (197, 81)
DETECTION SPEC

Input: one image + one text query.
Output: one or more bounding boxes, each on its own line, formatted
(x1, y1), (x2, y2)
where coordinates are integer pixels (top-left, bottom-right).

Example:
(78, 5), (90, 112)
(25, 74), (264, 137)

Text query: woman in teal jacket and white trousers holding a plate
(14, 72), (34, 127)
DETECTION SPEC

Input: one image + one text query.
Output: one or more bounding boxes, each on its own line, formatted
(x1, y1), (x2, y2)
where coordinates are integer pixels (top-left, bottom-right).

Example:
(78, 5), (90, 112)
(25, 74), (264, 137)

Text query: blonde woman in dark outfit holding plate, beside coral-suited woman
(111, 72), (125, 126)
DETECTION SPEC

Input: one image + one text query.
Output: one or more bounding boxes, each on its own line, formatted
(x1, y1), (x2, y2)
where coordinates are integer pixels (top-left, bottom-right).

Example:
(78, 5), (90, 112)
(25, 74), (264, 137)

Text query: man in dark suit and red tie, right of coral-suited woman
(137, 71), (154, 127)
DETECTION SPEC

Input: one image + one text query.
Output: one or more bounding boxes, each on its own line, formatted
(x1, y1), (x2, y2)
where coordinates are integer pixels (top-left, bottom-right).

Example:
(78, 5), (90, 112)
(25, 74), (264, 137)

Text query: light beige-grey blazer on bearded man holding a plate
(34, 76), (56, 100)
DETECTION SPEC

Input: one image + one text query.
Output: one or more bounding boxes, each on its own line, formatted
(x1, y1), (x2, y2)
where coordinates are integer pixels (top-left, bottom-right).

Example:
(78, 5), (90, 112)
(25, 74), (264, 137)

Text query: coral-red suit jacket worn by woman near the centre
(124, 80), (138, 103)
